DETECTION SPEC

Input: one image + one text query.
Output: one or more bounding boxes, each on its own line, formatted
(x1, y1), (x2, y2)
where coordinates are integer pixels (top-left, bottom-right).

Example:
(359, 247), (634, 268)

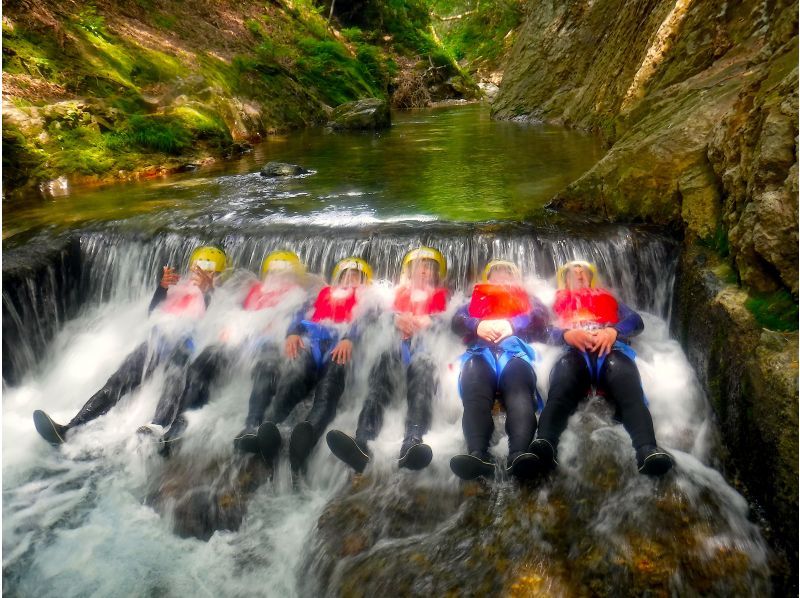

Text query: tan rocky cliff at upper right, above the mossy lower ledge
(494, 0), (798, 295)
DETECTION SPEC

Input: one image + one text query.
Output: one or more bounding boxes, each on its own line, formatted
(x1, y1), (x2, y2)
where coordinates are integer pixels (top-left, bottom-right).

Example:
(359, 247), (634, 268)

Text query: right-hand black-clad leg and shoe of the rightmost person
(598, 350), (672, 475)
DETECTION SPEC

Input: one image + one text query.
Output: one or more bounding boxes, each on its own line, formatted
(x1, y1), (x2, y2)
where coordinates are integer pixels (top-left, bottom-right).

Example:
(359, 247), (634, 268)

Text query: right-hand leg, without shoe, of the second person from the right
(500, 357), (536, 463)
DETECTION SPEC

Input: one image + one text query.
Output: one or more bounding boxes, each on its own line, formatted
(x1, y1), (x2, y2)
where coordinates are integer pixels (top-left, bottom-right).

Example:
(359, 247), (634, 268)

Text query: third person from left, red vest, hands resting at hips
(242, 257), (372, 471)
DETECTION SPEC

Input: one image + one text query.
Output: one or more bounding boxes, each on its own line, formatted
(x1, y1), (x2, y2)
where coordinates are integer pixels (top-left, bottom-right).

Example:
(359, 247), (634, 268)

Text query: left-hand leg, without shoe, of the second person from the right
(460, 356), (496, 456)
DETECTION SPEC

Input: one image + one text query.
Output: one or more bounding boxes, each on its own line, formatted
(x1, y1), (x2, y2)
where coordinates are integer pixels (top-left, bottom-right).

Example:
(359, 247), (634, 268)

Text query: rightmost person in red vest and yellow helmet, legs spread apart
(529, 261), (672, 475)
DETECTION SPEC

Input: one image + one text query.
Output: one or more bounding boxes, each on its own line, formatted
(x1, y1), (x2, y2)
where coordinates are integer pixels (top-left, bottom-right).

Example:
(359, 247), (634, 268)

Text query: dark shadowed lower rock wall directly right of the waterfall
(673, 246), (798, 595)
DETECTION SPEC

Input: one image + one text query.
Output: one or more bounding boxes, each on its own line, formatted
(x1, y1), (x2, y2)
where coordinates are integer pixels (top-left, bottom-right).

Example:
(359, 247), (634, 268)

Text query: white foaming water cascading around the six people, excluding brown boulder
(3, 225), (766, 596)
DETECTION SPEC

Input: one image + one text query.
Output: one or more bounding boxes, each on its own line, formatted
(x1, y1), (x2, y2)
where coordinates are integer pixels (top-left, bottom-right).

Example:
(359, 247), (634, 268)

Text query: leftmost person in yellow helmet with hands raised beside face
(33, 246), (226, 445)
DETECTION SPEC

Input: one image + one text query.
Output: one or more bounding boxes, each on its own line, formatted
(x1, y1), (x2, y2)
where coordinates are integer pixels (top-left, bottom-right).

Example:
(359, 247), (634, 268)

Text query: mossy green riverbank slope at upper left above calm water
(3, 0), (478, 198)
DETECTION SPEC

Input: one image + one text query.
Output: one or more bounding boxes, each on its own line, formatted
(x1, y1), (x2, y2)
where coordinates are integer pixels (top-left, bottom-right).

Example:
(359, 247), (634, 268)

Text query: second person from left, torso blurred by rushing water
(139, 251), (312, 456)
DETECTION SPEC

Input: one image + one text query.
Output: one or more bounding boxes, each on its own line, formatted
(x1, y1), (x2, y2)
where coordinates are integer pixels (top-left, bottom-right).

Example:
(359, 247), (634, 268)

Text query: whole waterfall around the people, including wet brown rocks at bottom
(3, 222), (769, 596)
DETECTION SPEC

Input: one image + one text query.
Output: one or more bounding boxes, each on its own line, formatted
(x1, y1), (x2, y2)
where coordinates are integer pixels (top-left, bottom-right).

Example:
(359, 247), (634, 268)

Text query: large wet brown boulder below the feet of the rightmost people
(301, 405), (770, 596)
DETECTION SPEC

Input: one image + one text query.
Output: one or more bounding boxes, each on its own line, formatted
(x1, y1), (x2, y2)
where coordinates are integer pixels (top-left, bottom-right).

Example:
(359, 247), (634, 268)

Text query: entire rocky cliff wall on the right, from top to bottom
(494, 0), (798, 583)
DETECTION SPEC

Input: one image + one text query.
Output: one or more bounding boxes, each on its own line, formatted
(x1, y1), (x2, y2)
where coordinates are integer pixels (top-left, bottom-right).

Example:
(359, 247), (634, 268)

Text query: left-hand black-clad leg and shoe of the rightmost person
(529, 349), (591, 467)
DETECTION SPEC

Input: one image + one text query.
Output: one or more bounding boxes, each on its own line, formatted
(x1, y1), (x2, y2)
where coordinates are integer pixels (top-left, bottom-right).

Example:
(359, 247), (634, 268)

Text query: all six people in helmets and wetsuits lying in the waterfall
(33, 246), (672, 480)
